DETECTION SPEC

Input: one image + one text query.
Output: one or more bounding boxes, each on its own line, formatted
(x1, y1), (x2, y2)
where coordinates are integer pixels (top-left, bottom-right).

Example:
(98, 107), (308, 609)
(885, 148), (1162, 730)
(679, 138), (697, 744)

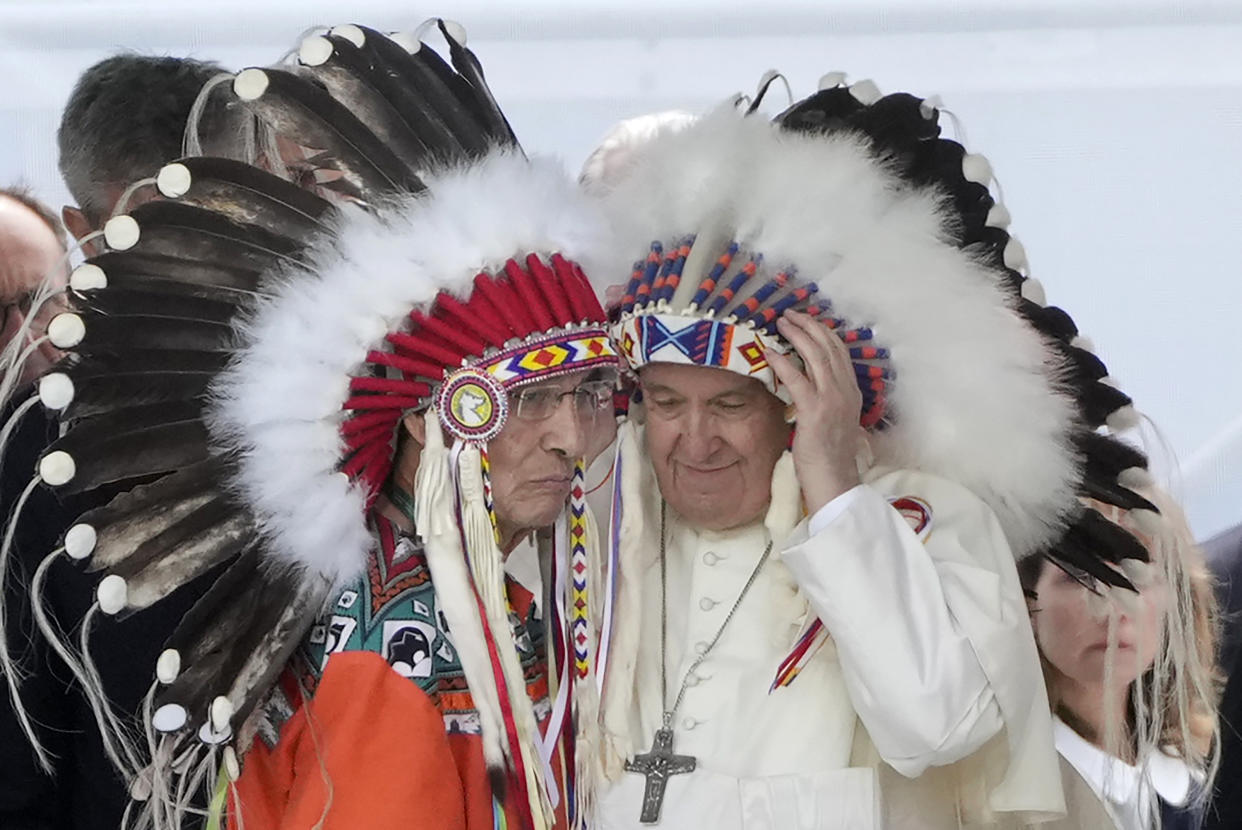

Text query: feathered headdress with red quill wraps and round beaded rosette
(2, 21), (617, 825)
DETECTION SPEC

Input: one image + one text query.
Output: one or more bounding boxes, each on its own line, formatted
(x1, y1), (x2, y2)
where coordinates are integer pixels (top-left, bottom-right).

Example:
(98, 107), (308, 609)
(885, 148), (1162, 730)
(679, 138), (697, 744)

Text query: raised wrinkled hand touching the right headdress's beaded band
(766, 311), (863, 516)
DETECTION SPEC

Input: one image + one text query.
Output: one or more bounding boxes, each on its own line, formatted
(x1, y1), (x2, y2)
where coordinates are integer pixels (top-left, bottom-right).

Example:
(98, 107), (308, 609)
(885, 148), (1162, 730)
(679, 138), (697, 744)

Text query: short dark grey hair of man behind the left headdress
(56, 53), (250, 226)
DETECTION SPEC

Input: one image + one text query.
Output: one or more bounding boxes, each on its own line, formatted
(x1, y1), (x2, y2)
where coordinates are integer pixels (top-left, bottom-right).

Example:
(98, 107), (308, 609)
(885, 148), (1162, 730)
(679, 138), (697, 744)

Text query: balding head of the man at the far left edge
(0, 194), (65, 375)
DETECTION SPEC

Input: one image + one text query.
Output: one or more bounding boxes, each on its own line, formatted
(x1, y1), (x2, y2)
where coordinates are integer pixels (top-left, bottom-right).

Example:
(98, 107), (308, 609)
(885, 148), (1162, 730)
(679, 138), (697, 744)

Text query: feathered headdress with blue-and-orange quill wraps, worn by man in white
(606, 77), (1151, 585)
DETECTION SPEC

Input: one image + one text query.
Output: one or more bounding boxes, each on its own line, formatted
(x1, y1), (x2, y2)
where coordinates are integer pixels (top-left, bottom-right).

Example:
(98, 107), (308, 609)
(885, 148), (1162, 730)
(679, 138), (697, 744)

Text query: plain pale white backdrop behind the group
(0, 0), (1242, 538)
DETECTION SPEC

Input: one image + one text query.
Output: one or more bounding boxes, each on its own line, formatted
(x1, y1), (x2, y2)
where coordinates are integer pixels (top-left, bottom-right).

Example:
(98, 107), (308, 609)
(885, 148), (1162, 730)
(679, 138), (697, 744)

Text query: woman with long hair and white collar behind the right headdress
(1018, 491), (1220, 830)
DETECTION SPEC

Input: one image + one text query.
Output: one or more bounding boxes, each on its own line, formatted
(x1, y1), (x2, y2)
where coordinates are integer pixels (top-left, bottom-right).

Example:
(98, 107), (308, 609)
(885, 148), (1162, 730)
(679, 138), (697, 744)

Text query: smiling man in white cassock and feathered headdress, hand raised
(576, 74), (1137, 830)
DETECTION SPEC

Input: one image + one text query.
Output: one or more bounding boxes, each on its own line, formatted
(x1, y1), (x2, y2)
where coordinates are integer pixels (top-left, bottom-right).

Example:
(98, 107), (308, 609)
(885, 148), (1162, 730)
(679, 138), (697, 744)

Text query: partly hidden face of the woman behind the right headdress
(1032, 564), (1165, 691)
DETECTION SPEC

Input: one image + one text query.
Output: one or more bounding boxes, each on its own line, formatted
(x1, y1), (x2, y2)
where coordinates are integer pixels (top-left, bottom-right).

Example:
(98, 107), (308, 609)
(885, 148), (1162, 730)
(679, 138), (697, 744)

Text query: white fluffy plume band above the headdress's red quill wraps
(210, 150), (605, 583)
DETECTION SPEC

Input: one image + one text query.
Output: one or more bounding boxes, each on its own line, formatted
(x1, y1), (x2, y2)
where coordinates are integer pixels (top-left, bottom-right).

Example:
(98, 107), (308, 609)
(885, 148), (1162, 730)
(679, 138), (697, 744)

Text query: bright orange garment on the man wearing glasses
(229, 586), (568, 830)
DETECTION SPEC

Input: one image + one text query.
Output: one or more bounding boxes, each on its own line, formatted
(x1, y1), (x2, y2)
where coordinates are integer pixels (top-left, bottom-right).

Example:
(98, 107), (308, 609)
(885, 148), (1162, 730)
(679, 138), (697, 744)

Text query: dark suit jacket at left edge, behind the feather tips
(0, 397), (205, 830)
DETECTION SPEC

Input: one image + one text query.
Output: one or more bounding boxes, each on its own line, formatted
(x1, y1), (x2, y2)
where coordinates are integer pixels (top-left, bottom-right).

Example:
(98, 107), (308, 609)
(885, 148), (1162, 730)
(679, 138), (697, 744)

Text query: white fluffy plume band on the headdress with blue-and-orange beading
(596, 107), (1078, 555)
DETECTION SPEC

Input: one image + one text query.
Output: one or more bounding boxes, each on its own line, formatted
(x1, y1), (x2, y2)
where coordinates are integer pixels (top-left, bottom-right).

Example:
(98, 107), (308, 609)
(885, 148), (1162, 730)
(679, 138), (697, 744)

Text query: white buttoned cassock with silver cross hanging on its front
(595, 444), (1064, 830)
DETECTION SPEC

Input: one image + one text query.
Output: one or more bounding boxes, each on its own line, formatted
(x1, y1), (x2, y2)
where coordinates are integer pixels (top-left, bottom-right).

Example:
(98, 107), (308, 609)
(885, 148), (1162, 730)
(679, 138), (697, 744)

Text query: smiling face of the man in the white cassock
(640, 363), (789, 531)
